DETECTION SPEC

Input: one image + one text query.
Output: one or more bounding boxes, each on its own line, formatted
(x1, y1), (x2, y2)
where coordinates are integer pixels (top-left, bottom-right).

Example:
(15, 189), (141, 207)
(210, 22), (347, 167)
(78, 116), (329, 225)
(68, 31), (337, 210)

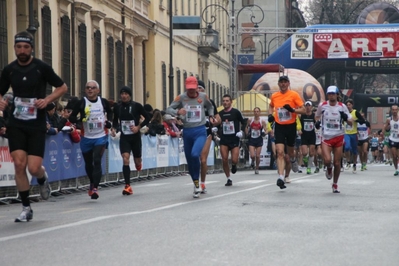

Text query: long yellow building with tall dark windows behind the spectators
(0, 0), (229, 110)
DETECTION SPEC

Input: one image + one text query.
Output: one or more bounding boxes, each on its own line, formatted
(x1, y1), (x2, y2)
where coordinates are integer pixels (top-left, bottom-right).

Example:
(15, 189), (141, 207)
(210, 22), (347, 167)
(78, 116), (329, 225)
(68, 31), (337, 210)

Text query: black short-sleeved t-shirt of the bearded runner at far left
(0, 58), (64, 131)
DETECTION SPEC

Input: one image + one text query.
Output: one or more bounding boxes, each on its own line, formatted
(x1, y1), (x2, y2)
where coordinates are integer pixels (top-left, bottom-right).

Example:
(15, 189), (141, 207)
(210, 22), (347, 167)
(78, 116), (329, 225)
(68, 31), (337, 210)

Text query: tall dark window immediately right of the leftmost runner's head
(41, 6), (53, 95)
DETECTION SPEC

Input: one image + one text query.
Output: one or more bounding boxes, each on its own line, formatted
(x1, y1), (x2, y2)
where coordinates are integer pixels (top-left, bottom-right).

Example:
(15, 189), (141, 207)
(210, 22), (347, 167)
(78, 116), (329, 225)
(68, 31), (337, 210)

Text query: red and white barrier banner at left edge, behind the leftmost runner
(0, 137), (15, 187)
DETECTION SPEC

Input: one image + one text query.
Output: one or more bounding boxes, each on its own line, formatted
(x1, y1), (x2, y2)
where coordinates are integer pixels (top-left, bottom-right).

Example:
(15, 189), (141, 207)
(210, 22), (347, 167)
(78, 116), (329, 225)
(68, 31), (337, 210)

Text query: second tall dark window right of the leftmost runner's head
(61, 16), (73, 98)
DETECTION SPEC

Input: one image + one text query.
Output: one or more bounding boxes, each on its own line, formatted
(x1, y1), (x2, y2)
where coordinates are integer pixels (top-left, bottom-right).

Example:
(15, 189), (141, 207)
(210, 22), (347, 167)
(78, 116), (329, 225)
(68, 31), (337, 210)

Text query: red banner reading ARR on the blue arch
(313, 32), (399, 59)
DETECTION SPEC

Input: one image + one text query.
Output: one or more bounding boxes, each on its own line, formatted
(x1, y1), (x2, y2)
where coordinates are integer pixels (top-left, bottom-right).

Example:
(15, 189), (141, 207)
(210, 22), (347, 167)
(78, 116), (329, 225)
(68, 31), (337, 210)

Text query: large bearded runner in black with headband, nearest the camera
(0, 31), (68, 222)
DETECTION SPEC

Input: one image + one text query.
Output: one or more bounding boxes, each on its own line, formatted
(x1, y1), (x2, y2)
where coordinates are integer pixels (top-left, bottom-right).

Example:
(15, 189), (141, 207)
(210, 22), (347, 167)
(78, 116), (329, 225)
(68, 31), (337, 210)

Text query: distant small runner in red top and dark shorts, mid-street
(245, 107), (267, 174)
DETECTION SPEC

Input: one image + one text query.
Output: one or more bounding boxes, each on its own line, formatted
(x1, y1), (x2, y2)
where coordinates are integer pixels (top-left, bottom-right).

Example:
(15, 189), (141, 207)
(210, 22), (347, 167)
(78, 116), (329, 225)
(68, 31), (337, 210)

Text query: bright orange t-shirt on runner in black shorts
(270, 90), (303, 125)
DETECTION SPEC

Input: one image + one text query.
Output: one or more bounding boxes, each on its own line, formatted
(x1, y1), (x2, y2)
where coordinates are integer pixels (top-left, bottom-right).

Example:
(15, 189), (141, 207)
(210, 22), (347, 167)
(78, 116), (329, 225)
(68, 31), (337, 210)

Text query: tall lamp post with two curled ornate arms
(201, 0), (264, 98)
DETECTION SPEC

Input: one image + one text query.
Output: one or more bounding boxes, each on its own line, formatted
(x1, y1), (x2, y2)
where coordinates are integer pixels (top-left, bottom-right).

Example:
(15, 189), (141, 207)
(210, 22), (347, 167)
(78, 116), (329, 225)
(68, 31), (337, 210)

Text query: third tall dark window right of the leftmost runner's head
(78, 24), (87, 96)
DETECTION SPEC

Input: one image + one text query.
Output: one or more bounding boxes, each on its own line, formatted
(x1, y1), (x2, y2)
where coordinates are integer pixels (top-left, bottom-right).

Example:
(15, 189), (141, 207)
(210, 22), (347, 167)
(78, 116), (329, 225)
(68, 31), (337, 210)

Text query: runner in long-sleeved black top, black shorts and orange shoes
(111, 86), (151, 195)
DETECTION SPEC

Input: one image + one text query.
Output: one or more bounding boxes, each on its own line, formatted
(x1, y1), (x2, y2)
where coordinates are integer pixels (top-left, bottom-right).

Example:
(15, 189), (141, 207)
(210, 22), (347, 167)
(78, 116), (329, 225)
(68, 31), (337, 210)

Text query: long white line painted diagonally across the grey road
(0, 175), (314, 242)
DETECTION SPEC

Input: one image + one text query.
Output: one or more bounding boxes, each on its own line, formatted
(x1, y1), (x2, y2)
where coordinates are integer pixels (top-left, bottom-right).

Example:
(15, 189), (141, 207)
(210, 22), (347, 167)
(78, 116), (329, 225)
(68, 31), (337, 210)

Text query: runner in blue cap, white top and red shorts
(315, 86), (353, 193)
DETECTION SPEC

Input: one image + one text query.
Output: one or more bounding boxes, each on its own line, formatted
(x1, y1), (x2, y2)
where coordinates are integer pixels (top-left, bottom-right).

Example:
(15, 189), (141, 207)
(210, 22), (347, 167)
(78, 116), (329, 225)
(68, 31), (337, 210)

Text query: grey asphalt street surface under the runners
(0, 164), (399, 266)
